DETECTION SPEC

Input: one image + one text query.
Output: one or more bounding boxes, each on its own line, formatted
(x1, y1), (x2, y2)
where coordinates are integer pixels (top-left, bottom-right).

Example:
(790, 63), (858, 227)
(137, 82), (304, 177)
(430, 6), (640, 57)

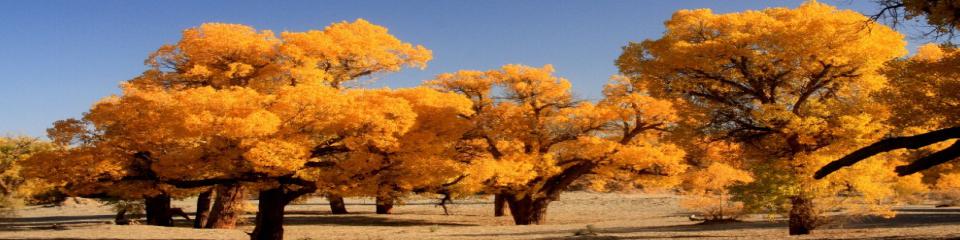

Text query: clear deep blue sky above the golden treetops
(0, 0), (912, 137)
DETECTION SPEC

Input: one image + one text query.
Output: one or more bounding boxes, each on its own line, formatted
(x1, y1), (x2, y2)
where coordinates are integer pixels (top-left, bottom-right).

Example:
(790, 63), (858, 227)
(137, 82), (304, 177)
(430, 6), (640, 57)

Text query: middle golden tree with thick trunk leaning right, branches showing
(429, 65), (686, 225)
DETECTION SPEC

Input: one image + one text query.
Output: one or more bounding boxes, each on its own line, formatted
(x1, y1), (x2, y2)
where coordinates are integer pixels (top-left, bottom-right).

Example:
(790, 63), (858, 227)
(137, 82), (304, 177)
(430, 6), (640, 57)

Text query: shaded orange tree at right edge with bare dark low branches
(815, 44), (960, 178)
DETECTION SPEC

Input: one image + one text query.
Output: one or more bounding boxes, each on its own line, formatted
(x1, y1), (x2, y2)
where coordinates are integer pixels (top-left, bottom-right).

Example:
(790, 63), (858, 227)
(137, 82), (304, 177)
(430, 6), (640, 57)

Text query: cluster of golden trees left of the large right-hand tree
(15, 20), (686, 239)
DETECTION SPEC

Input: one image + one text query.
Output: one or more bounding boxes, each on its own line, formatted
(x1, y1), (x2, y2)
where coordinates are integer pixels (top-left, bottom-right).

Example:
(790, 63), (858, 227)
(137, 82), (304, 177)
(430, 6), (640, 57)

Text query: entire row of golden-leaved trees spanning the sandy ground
(0, 2), (960, 239)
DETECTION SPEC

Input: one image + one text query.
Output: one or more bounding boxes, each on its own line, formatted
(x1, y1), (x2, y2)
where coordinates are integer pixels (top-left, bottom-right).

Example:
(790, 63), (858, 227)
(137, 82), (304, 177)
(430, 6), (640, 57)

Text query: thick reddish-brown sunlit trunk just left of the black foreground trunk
(207, 184), (244, 229)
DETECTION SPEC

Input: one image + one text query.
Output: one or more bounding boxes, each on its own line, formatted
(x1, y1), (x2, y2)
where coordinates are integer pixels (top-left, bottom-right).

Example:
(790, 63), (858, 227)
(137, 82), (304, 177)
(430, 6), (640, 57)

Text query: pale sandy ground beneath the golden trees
(0, 192), (960, 240)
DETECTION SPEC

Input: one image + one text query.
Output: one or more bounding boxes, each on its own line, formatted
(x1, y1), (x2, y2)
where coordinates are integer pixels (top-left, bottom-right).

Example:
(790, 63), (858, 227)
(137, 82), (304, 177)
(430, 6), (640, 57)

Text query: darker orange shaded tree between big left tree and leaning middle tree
(320, 87), (472, 214)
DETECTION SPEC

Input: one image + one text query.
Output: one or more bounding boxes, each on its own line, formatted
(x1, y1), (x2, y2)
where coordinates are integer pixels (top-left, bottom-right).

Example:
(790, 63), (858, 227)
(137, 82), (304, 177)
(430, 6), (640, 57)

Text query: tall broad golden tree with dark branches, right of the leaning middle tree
(617, 2), (906, 235)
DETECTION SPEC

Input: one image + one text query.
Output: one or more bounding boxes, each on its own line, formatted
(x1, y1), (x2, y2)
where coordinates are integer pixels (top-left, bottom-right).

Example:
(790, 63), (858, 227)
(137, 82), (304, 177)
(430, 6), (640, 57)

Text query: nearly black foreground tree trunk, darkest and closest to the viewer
(250, 186), (287, 240)
